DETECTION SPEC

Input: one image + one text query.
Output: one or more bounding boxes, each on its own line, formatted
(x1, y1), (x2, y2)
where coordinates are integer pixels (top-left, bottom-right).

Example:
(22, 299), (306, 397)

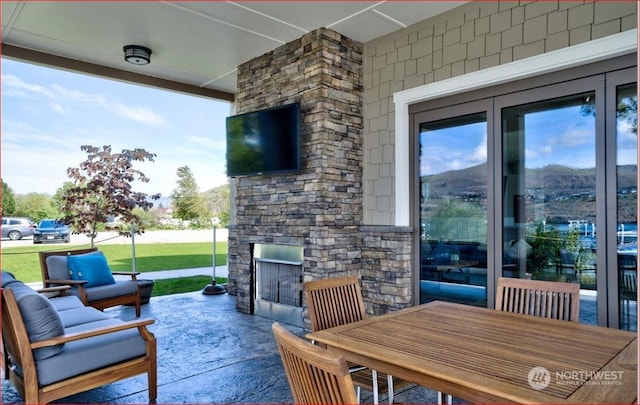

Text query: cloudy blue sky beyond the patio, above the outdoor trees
(0, 58), (231, 196)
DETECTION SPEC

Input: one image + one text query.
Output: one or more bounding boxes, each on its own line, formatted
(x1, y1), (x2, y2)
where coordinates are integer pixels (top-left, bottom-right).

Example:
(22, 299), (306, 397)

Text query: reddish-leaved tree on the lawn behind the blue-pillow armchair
(62, 145), (160, 247)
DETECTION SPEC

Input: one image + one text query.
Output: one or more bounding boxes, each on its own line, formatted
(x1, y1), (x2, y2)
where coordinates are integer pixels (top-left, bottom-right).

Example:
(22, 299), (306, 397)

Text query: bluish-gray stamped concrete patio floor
(2, 292), (437, 404)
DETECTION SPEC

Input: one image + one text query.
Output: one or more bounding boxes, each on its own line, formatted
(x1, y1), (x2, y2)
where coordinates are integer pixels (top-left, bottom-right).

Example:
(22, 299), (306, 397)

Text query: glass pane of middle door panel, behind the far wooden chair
(502, 92), (598, 324)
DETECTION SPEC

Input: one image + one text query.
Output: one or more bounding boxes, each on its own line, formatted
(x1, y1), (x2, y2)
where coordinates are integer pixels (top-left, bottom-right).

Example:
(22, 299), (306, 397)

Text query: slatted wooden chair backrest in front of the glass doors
(496, 277), (580, 322)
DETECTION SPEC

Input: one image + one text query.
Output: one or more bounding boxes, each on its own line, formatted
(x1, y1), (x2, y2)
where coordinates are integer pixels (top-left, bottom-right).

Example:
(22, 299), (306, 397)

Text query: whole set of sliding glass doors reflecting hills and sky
(411, 62), (638, 330)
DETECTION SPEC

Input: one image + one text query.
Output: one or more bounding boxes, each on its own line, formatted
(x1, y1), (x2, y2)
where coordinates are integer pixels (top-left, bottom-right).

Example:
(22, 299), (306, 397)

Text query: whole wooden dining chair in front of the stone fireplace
(305, 277), (408, 404)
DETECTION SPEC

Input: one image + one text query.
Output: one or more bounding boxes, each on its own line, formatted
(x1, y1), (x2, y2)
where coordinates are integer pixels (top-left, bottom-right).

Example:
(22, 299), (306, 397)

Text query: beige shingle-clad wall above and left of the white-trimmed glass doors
(363, 1), (638, 225)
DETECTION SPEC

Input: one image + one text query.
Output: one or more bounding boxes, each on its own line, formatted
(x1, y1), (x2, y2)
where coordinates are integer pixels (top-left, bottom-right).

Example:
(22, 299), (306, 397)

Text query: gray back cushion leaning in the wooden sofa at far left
(6, 281), (64, 360)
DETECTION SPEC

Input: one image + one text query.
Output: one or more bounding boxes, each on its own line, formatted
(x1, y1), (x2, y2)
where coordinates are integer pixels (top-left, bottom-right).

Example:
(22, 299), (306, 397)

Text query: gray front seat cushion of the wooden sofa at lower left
(36, 318), (146, 385)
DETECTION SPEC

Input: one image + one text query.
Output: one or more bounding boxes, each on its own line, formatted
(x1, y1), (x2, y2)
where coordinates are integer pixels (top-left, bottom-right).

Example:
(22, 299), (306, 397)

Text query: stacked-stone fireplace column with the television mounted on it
(228, 28), (411, 326)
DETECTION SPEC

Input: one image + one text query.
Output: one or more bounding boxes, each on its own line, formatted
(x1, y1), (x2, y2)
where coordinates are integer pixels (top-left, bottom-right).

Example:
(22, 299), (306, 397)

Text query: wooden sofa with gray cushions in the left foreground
(0, 271), (157, 404)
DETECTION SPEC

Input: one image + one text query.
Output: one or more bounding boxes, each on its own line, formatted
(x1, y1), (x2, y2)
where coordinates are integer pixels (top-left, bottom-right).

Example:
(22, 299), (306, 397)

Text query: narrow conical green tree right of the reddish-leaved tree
(171, 166), (210, 221)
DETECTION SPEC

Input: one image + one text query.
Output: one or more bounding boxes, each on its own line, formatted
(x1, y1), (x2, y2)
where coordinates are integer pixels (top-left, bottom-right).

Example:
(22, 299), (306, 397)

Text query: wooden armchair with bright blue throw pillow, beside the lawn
(39, 248), (140, 317)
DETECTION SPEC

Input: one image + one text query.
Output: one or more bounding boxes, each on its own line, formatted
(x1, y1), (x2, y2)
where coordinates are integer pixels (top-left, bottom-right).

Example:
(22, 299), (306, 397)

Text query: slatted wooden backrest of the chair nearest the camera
(273, 322), (358, 404)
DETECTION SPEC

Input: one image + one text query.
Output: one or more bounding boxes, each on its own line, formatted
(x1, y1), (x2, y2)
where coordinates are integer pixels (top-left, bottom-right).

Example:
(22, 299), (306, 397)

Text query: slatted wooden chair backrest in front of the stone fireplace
(304, 277), (367, 332)
